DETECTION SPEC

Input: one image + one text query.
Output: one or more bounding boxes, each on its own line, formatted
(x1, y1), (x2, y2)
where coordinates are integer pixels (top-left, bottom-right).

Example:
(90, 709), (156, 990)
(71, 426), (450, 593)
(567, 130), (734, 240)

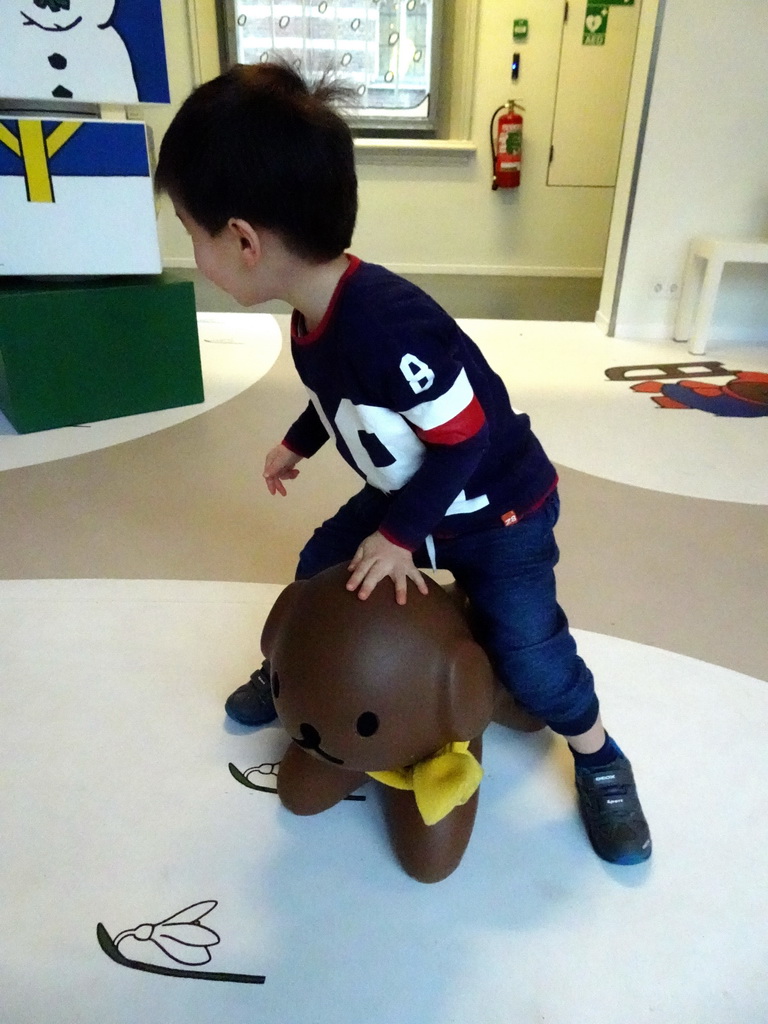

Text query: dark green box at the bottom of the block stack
(0, 276), (204, 434)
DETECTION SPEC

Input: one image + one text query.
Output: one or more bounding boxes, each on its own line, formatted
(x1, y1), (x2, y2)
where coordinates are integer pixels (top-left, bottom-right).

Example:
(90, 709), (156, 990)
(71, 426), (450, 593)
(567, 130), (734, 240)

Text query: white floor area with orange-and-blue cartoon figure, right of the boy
(462, 321), (768, 505)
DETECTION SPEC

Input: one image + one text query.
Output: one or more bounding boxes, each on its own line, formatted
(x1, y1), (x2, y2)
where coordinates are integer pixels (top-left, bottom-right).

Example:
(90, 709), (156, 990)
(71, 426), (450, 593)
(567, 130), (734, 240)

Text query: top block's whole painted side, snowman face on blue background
(0, 0), (170, 103)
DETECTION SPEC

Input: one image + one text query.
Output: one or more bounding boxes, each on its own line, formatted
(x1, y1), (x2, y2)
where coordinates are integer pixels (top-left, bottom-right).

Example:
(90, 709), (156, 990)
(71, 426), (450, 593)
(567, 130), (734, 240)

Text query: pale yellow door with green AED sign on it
(547, 0), (642, 187)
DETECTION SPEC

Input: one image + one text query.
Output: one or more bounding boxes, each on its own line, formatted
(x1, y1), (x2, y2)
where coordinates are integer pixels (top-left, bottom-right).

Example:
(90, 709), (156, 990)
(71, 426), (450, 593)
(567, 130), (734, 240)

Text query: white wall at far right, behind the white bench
(600, 0), (768, 341)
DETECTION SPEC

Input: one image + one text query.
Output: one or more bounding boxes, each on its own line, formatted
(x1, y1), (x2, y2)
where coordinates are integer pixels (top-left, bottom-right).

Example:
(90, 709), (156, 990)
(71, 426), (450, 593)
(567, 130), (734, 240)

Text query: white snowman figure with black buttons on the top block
(0, 0), (138, 103)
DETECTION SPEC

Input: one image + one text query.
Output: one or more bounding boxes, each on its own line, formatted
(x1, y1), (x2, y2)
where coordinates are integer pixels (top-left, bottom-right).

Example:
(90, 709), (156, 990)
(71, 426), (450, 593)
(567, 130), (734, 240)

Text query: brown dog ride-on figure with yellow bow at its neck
(261, 565), (543, 882)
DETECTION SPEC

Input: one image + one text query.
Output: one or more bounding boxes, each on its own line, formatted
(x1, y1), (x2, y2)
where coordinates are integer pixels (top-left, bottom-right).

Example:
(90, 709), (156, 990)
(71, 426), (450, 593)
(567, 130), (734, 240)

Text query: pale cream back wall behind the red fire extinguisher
(157, 0), (618, 275)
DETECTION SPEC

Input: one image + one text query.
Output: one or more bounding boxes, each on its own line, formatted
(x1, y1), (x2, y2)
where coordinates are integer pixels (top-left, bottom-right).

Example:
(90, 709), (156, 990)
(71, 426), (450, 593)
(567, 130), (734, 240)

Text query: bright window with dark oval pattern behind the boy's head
(219, 0), (440, 138)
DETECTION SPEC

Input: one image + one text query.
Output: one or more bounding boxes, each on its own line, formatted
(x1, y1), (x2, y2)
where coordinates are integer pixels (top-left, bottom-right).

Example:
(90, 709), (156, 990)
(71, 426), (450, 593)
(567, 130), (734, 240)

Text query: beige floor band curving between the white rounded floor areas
(0, 303), (768, 680)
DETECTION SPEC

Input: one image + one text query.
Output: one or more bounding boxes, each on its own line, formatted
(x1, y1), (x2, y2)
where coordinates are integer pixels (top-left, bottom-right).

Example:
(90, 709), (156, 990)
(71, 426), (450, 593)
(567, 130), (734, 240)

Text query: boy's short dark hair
(155, 61), (357, 262)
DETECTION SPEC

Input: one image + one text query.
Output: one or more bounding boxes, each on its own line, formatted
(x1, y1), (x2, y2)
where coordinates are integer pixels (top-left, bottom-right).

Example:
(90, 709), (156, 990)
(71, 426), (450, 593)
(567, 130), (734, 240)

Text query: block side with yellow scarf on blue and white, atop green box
(0, 118), (162, 274)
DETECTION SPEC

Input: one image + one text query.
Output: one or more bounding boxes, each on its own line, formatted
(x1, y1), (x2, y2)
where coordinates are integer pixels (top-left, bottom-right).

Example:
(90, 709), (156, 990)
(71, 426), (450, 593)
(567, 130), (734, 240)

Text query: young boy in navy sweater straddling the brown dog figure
(156, 63), (651, 864)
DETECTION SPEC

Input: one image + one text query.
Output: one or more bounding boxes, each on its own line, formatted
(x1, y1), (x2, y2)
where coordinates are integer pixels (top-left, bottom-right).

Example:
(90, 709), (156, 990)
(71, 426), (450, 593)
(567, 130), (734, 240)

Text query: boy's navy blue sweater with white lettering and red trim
(284, 256), (557, 551)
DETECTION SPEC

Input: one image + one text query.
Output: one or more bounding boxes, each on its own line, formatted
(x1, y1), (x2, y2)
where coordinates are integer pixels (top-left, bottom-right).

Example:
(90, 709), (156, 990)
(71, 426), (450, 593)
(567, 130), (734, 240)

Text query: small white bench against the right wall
(674, 238), (768, 355)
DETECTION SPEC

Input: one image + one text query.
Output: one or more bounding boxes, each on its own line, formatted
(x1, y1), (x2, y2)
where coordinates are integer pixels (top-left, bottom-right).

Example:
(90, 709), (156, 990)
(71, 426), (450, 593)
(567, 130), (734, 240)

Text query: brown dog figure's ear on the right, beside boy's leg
(445, 637), (496, 740)
